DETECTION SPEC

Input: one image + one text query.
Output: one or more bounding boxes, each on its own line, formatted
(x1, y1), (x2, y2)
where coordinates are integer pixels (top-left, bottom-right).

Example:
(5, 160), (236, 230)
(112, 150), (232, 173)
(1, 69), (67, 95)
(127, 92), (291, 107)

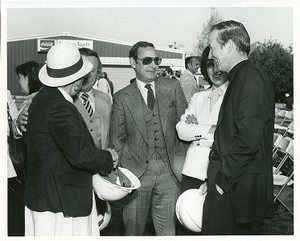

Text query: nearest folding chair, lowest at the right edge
(274, 145), (294, 214)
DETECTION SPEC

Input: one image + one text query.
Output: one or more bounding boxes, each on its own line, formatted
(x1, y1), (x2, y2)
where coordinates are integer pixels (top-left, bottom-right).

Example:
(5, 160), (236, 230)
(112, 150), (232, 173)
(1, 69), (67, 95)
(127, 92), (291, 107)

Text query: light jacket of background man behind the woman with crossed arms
(180, 70), (200, 101)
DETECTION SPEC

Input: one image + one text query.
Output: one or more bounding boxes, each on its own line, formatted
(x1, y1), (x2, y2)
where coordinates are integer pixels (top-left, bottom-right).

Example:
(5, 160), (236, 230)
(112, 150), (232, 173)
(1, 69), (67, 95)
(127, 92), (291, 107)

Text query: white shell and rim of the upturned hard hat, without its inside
(93, 167), (141, 201)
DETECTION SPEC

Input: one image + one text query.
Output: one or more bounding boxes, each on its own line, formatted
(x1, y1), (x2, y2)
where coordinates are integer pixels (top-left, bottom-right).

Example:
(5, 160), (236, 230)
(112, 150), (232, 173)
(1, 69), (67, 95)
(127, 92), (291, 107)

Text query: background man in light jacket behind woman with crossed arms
(180, 56), (201, 101)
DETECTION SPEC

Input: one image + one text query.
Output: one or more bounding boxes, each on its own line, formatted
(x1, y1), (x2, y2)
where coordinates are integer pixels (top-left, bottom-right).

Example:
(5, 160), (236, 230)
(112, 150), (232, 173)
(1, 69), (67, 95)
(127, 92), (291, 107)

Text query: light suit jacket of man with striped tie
(74, 89), (112, 149)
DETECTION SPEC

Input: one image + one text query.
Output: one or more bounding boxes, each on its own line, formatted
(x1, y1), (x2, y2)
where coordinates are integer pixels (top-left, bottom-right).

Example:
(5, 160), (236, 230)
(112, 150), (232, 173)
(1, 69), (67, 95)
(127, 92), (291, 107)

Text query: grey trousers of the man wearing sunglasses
(123, 154), (180, 236)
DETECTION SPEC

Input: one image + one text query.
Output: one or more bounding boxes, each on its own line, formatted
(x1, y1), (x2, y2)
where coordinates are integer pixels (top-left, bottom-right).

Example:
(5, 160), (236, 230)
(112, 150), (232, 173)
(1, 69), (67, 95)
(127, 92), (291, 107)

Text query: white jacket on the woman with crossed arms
(176, 82), (228, 180)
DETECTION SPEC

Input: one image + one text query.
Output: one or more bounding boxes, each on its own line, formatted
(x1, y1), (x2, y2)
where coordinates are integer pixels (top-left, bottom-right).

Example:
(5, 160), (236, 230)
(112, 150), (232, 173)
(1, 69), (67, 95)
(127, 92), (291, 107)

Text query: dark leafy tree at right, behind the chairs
(249, 40), (293, 103)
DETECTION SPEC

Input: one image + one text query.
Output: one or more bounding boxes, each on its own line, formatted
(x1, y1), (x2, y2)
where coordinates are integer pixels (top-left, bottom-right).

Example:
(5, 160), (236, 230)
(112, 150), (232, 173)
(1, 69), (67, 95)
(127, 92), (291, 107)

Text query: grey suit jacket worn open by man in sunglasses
(110, 78), (188, 181)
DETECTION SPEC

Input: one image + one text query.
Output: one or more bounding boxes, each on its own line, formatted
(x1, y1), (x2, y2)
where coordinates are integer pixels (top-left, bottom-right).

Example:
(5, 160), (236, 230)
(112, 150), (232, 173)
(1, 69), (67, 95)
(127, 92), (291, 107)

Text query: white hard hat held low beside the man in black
(176, 189), (206, 232)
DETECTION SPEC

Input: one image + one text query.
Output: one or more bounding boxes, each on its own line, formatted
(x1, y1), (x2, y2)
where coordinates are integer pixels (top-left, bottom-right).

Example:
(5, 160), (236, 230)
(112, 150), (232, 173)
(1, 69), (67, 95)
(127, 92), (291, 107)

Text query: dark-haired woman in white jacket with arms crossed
(176, 47), (229, 234)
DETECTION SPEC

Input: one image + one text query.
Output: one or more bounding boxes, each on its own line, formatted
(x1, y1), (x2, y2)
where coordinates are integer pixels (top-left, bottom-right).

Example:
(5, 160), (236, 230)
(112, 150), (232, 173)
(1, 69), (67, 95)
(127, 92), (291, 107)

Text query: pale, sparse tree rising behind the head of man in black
(194, 8), (223, 56)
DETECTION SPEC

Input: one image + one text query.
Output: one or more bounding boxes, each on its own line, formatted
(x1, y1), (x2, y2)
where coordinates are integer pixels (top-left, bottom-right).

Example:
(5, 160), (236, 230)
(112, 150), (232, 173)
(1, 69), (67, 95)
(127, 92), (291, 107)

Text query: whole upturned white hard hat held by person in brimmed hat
(93, 167), (141, 201)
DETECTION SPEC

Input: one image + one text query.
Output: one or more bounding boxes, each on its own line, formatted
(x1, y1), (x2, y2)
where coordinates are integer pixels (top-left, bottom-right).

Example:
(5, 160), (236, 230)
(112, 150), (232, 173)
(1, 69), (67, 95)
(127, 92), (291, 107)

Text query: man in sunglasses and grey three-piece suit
(110, 42), (187, 236)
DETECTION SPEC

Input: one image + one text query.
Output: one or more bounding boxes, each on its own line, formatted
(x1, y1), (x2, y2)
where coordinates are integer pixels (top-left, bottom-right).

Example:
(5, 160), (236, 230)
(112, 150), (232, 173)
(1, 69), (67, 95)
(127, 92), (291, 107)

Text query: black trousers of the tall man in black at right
(202, 151), (252, 235)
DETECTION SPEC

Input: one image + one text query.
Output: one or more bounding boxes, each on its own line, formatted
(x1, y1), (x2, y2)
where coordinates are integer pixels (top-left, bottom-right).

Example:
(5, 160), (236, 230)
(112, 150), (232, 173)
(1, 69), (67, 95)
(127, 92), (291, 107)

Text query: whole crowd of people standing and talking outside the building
(8, 20), (275, 236)
